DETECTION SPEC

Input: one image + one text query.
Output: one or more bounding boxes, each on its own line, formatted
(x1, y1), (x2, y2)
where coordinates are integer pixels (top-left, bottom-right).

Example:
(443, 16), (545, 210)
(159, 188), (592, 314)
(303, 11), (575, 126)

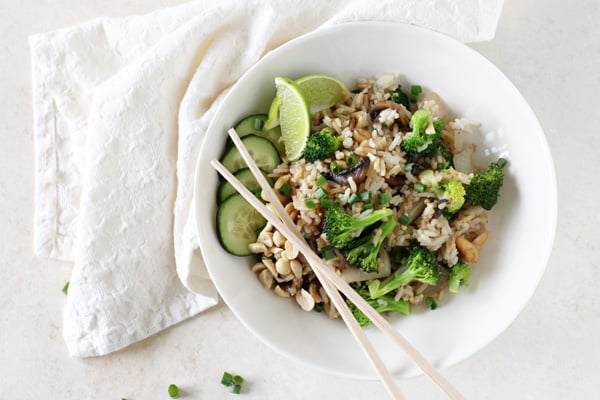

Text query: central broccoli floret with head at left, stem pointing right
(323, 205), (394, 249)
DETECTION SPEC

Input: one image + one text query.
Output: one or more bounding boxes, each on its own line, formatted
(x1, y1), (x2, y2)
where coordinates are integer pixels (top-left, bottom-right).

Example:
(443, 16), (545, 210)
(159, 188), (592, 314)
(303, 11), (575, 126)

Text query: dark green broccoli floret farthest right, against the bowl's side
(466, 158), (507, 210)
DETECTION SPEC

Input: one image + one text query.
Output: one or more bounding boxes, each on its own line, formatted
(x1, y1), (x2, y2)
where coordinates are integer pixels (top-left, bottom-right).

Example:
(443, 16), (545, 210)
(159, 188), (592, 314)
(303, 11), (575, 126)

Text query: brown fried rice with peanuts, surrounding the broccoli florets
(250, 75), (488, 318)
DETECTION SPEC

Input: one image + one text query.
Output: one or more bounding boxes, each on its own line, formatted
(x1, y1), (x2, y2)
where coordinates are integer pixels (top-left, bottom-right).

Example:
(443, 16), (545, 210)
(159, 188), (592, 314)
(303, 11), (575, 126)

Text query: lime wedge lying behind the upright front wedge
(295, 74), (348, 114)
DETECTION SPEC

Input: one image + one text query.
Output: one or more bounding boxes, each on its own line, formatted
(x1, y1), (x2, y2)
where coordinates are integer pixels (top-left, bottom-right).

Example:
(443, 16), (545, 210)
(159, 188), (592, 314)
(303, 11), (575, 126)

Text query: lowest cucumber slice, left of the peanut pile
(217, 193), (267, 256)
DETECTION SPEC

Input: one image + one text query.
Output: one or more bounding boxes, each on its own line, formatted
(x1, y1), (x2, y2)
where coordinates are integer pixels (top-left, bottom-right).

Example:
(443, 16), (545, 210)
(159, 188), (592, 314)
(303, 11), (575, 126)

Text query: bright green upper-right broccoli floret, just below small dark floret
(401, 109), (444, 156)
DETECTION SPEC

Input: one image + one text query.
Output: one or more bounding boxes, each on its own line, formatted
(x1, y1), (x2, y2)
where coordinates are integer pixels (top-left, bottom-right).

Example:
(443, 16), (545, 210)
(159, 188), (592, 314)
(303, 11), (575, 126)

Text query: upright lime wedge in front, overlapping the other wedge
(275, 77), (310, 161)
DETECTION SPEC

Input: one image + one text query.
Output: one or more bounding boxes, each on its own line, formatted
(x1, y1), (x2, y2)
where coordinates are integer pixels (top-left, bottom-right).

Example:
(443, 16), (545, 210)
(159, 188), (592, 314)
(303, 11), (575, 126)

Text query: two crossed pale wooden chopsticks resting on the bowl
(211, 128), (464, 400)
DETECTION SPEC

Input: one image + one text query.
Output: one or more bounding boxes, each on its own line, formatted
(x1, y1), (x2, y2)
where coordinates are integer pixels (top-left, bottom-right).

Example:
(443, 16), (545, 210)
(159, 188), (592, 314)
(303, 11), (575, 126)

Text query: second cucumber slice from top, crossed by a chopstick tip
(221, 134), (281, 173)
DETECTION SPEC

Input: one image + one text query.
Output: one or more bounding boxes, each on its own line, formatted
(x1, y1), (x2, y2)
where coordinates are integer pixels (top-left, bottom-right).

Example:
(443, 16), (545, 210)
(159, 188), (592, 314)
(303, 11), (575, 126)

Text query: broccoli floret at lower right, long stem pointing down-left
(369, 246), (440, 299)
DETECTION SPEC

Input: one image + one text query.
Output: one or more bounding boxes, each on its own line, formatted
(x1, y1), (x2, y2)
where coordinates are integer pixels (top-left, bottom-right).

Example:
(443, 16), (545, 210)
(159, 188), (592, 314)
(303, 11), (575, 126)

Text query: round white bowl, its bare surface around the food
(195, 22), (557, 379)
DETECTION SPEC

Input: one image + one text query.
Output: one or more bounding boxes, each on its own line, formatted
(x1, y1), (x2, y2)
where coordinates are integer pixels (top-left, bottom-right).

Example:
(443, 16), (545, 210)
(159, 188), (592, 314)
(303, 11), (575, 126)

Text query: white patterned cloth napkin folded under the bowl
(29, 0), (502, 357)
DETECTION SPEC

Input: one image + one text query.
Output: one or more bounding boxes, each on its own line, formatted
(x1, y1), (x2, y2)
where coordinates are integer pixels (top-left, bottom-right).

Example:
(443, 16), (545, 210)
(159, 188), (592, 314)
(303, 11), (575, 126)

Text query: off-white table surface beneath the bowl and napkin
(0, 0), (600, 400)
